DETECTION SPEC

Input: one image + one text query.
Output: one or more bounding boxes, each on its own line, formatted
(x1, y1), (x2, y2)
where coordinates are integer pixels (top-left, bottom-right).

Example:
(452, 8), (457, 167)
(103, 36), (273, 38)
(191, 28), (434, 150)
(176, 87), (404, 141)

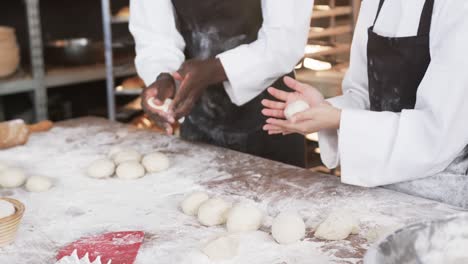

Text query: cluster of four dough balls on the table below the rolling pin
(87, 147), (170, 180)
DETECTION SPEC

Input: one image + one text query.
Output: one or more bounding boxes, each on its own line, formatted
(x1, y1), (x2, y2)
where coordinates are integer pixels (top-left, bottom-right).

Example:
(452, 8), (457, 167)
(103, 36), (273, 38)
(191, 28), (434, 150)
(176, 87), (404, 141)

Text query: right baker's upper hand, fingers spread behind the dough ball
(262, 76), (325, 119)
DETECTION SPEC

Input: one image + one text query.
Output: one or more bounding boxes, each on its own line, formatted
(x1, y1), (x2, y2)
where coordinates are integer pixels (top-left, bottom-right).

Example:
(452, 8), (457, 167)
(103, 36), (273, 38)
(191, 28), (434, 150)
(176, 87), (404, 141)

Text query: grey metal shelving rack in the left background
(0, 0), (136, 121)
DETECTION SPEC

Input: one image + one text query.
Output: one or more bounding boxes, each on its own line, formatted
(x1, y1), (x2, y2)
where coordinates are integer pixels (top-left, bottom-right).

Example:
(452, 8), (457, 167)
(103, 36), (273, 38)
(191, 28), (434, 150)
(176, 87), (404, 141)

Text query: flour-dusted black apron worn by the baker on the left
(172, 0), (305, 166)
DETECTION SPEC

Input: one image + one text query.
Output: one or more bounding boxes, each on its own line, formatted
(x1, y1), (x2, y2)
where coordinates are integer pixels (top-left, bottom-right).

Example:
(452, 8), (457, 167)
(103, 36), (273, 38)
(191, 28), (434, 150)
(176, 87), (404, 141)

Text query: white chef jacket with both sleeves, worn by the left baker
(130, 0), (314, 105)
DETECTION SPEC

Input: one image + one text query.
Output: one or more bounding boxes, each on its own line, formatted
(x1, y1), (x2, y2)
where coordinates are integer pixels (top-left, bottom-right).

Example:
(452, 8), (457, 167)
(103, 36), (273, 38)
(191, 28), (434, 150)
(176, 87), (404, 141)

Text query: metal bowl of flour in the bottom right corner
(364, 214), (468, 264)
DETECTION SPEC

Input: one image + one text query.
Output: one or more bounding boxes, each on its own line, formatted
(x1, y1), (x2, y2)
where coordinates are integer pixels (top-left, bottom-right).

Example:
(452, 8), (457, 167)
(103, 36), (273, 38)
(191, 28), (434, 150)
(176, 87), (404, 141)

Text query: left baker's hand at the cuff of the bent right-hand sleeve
(169, 58), (227, 119)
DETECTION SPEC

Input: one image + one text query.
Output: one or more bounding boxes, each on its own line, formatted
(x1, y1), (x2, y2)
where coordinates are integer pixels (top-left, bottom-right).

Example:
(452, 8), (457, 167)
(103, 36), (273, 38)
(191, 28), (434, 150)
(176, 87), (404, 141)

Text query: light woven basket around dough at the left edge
(0, 198), (24, 247)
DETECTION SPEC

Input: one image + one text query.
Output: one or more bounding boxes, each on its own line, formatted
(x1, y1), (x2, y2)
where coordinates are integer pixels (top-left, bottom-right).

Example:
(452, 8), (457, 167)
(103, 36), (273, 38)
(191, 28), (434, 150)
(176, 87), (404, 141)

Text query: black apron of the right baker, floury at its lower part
(367, 0), (468, 209)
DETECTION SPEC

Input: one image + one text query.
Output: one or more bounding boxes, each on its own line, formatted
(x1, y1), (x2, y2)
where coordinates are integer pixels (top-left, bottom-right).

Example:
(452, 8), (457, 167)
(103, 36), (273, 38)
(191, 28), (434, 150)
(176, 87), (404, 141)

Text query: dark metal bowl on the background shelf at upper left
(45, 38), (104, 66)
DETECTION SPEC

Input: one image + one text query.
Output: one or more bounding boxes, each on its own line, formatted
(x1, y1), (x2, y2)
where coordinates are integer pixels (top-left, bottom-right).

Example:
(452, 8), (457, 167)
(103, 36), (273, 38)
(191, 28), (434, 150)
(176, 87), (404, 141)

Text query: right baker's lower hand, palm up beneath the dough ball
(263, 101), (341, 135)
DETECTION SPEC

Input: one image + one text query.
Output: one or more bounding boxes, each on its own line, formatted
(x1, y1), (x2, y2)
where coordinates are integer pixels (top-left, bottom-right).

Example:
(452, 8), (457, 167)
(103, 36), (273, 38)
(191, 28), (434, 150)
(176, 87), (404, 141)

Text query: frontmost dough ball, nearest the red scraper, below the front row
(202, 236), (239, 261)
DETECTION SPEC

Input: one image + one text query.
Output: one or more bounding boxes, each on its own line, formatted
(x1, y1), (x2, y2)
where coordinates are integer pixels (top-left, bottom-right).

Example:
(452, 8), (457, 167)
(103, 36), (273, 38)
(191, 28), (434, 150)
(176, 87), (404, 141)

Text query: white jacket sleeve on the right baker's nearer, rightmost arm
(338, 1), (468, 187)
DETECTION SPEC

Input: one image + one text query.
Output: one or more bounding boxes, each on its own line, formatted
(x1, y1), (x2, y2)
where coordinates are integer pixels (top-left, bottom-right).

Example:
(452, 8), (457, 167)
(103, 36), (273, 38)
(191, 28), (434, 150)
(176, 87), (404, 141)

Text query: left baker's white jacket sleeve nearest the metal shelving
(129, 0), (185, 85)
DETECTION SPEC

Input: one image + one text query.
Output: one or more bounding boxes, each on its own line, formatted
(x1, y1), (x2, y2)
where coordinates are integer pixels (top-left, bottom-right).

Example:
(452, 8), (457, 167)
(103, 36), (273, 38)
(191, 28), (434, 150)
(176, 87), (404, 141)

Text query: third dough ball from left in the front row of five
(226, 203), (263, 232)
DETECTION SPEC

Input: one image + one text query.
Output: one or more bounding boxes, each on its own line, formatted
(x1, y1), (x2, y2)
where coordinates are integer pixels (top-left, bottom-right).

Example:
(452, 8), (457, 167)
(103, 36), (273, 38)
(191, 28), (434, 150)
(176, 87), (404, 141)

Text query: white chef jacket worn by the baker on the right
(319, 0), (468, 187)
